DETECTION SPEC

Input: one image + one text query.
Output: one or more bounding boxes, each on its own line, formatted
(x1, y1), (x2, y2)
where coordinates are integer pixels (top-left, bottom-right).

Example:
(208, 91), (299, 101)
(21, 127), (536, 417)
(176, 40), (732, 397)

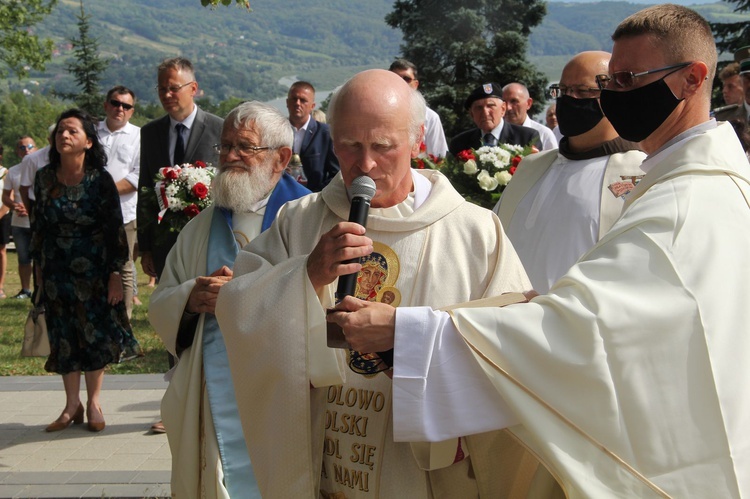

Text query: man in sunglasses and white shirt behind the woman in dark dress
(97, 85), (141, 318)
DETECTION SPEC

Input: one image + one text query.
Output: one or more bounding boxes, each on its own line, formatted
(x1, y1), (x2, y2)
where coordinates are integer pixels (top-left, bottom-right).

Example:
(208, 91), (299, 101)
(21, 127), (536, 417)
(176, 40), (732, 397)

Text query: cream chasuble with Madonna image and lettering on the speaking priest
(217, 170), (529, 499)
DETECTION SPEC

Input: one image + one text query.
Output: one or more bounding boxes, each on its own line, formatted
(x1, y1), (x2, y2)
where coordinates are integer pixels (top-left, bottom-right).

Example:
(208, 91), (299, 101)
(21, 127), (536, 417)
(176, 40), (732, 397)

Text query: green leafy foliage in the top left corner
(0, 0), (57, 78)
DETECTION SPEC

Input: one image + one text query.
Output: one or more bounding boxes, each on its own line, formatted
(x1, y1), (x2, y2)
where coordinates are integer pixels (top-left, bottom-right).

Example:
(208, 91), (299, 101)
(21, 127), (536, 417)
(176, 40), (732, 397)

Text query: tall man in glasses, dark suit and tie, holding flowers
(137, 57), (223, 278)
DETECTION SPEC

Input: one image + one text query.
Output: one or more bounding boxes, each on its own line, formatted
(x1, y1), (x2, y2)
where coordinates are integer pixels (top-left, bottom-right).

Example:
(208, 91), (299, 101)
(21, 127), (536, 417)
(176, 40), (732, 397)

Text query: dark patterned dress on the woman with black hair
(31, 165), (143, 374)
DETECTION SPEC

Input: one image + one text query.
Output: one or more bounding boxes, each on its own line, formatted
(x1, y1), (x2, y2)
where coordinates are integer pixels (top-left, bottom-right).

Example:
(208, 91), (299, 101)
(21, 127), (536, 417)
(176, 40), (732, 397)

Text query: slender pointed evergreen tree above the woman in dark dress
(63, 0), (109, 116)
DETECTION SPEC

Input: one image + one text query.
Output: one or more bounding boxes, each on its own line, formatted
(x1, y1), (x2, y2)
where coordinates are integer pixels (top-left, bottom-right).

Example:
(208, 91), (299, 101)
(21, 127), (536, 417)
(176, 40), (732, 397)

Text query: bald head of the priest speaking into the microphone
(328, 69), (425, 208)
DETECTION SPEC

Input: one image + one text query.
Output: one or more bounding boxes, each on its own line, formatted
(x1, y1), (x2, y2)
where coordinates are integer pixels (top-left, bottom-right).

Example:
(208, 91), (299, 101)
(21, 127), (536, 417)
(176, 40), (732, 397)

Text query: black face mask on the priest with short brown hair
(604, 78), (683, 142)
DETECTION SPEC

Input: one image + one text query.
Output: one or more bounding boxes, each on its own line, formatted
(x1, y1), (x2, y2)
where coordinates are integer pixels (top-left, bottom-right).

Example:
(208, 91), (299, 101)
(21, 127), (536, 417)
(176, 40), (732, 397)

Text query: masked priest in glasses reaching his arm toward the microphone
(328, 4), (750, 498)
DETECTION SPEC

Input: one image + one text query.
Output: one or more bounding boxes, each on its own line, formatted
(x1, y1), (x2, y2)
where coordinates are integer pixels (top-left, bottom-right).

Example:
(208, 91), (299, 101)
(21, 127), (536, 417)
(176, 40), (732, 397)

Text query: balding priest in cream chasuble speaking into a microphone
(216, 69), (530, 499)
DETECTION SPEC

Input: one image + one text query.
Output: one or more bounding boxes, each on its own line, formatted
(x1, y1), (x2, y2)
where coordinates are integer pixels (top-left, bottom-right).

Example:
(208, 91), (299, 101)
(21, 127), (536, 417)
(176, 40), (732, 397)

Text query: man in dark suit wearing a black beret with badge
(448, 83), (542, 156)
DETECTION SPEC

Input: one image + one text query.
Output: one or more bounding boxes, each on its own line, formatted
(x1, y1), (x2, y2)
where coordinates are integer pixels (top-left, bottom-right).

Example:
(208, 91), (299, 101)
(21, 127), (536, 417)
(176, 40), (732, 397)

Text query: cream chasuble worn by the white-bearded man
(149, 203), (265, 499)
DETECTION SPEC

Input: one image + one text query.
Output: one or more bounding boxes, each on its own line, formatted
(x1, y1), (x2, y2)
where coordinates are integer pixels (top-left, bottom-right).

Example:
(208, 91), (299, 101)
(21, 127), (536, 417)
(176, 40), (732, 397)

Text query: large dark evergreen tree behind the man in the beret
(385, 0), (547, 137)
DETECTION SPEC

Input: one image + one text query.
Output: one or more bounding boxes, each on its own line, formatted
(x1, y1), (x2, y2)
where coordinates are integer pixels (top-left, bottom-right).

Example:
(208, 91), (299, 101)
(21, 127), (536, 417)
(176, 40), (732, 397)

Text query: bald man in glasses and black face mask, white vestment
(495, 52), (646, 293)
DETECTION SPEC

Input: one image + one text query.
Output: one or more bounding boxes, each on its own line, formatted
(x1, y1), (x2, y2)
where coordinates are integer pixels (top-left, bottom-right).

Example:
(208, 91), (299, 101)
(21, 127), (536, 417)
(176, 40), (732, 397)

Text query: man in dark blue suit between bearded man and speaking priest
(286, 81), (339, 192)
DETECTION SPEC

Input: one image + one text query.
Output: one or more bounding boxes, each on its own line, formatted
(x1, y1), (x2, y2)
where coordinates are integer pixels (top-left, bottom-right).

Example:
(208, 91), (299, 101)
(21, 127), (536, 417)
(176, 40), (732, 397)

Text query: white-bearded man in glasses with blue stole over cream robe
(149, 102), (310, 498)
